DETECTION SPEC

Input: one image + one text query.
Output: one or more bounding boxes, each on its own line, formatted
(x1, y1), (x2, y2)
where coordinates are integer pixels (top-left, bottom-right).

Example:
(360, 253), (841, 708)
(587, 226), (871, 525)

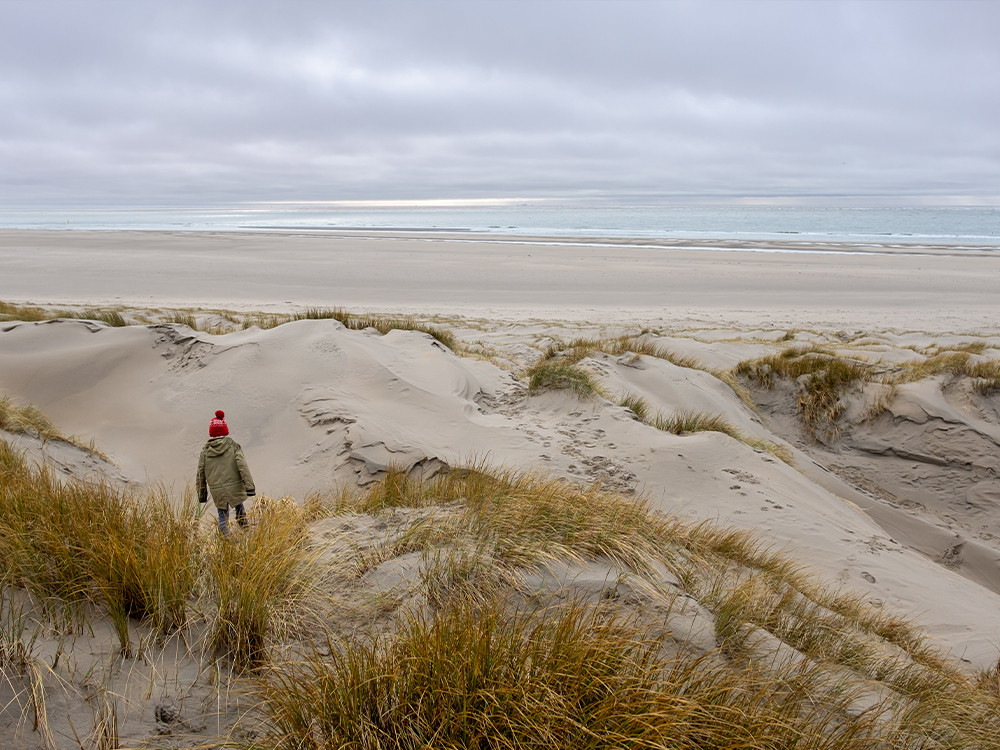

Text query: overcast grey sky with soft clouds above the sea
(0, 0), (1000, 208)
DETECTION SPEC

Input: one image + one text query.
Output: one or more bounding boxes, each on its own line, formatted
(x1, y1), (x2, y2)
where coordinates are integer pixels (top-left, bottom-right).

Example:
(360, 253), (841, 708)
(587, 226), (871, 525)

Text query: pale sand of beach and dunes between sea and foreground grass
(0, 231), (1000, 748)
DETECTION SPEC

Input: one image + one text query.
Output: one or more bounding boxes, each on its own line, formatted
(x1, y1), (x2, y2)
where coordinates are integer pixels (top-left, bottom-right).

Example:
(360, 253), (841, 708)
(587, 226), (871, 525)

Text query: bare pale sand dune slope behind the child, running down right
(0, 320), (1000, 668)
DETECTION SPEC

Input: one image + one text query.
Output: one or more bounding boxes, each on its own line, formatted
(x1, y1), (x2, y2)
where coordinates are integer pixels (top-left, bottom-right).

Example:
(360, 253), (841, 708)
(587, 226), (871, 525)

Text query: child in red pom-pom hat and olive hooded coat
(196, 409), (257, 536)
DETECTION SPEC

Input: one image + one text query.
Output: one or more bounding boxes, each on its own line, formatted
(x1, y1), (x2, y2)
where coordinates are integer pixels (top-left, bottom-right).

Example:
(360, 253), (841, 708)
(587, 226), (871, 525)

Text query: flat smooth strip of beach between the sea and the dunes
(0, 230), (1000, 332)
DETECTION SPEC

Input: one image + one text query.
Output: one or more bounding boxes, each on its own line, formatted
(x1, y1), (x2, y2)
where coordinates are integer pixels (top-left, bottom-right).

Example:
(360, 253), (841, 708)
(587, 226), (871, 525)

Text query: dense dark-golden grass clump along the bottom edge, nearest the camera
(258, 602), (886, 750)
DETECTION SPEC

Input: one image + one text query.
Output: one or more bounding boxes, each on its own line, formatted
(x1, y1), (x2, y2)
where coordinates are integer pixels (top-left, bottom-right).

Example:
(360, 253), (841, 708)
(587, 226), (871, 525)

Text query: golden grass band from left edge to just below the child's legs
(0, 441), (311, 671)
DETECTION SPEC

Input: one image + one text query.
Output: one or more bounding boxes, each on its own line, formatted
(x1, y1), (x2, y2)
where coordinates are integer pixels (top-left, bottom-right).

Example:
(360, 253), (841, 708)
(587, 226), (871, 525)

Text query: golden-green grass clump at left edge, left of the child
(0, 441), (197, 654)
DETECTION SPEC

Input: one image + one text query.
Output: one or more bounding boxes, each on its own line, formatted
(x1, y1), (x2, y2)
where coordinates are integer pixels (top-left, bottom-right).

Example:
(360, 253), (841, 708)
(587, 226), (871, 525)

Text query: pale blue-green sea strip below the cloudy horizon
(0, 203), (1000, 251)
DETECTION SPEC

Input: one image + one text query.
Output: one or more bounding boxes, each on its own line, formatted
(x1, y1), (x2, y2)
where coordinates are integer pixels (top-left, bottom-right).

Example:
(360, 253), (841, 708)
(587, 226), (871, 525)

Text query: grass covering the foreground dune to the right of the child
(254, 466), (1000, 750)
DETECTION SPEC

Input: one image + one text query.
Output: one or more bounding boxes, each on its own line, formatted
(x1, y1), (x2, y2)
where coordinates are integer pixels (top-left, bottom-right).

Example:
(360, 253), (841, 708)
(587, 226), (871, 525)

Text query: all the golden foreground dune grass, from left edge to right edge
(0, 447), (1000, 750)
